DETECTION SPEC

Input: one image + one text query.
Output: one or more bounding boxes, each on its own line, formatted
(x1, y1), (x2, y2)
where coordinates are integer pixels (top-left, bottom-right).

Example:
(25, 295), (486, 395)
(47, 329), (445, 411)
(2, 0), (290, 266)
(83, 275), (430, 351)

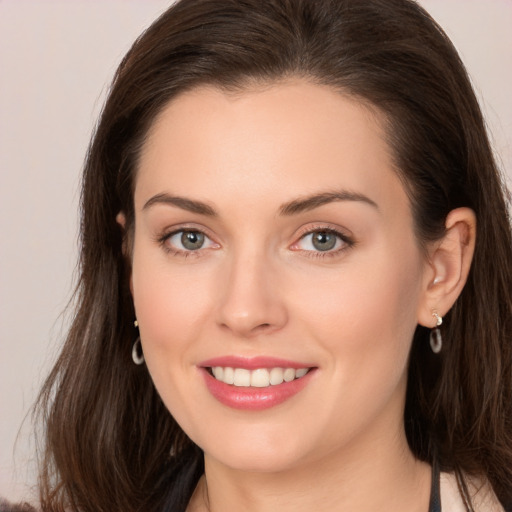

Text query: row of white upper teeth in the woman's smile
(211, 366), (309, 388)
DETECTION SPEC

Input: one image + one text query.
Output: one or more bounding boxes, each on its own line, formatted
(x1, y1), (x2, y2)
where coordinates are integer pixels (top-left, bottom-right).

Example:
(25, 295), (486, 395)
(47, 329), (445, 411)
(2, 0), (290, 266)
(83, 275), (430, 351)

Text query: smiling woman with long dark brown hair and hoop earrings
(24, 0), (512, 511)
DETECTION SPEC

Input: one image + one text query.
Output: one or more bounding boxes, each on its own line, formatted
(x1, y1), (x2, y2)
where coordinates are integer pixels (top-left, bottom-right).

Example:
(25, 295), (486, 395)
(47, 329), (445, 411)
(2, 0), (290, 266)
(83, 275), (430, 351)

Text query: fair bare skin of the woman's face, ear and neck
(119, 80), (475, 512)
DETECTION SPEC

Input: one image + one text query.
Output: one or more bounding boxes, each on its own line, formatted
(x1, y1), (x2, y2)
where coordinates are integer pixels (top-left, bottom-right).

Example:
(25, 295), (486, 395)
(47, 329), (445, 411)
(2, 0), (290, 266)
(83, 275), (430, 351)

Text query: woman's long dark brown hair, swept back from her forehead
(34, 0), (512, 512)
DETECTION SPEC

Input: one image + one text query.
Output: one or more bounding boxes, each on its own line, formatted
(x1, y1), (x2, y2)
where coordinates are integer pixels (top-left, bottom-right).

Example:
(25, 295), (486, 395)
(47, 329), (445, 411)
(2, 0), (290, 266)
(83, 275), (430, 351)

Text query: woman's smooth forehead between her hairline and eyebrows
(135, 80), (404, 218)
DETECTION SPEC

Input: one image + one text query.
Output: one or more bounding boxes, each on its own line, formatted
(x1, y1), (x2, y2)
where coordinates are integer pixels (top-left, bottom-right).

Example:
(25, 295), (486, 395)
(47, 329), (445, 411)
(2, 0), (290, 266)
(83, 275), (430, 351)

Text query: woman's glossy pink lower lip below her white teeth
(201, 368), (314, 411)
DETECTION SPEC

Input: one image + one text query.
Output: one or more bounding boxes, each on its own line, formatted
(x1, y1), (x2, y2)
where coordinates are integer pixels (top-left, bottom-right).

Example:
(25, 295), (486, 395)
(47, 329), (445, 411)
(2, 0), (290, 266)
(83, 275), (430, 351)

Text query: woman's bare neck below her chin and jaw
(189, 432), (431, 512)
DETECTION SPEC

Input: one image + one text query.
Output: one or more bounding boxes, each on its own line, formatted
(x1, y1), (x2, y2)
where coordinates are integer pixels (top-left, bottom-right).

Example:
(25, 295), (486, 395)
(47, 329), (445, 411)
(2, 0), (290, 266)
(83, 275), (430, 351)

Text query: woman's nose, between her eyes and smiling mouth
(217, 249), (288, 338)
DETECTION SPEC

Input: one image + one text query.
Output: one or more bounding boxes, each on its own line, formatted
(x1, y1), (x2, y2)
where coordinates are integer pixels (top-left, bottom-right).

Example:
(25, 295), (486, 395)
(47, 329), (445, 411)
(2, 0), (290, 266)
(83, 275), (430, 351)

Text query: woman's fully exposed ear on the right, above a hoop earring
(418, 208), (476, 327)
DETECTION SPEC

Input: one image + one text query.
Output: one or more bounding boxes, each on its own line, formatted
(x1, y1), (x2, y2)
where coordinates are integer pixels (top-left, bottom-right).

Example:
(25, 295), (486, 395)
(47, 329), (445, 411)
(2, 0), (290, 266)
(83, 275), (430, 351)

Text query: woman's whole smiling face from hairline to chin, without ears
(131, 81), (428, 471)
